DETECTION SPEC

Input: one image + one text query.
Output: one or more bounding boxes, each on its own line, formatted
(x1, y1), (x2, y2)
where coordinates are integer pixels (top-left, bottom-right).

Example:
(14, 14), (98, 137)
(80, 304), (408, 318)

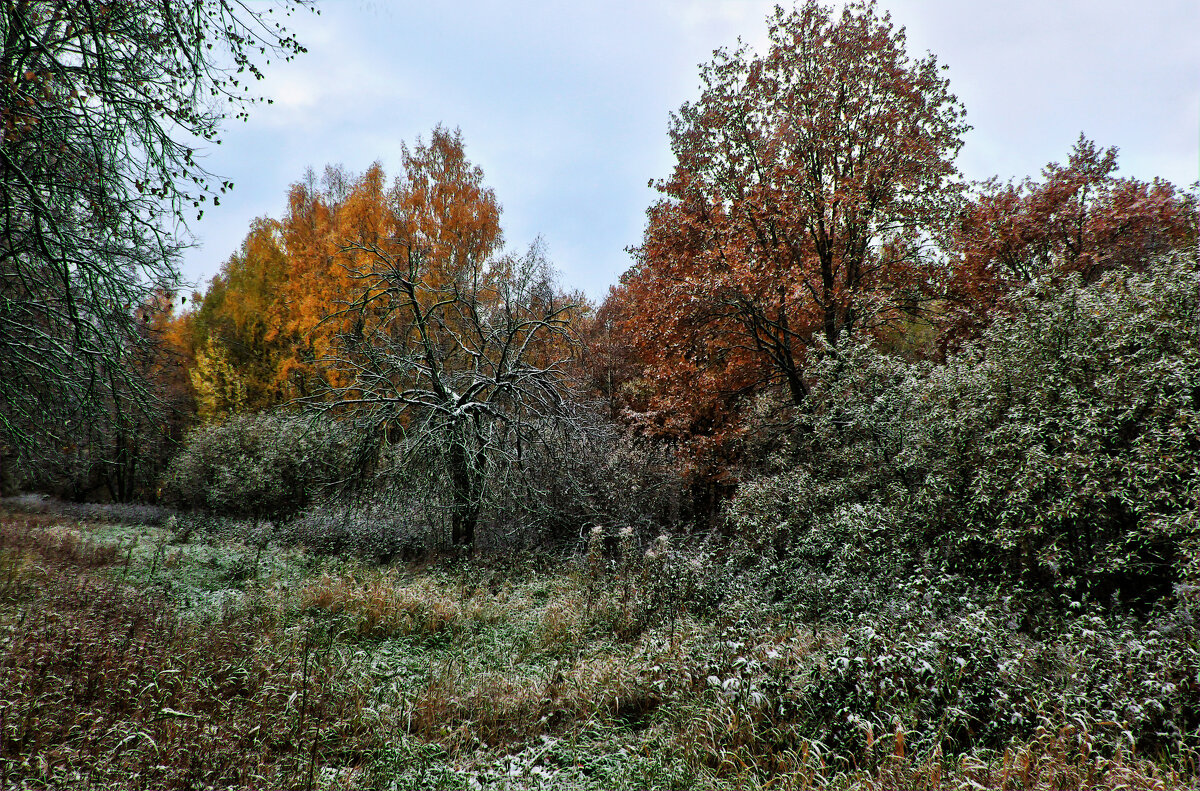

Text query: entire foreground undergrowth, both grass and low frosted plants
(0, 514), (1200, 790)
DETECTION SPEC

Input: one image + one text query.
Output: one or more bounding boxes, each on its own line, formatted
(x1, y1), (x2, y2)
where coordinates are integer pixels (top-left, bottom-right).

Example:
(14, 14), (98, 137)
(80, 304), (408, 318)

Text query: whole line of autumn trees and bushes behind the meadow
(6, 2), (1200, 606)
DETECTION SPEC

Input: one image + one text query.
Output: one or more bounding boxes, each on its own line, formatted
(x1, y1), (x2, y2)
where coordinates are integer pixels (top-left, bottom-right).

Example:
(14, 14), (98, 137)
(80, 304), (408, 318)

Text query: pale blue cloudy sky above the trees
(177, 0), (1200, 300)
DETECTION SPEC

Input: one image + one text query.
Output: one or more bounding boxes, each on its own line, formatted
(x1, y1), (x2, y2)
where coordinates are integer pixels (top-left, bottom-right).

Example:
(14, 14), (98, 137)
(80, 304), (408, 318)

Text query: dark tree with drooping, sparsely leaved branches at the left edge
(0, 0), (308, 477)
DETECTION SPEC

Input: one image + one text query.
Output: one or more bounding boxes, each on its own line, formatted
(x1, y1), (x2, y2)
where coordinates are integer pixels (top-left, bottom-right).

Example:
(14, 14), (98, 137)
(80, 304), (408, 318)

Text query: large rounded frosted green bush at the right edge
(914, 258), (1200, 603)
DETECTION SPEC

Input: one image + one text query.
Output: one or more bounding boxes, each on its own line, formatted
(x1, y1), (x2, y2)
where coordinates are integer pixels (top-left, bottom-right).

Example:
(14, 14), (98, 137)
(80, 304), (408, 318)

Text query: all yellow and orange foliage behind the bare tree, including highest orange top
(192, 147), (511, 413)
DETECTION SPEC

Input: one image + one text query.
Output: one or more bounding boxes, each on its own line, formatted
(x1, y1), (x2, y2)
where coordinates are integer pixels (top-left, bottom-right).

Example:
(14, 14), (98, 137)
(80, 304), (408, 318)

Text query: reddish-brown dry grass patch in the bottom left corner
(0, 513), (376, 789)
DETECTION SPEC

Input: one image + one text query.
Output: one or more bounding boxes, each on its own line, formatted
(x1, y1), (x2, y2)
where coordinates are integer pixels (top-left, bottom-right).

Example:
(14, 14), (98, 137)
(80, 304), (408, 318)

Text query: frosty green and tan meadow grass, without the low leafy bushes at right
(0, 504), (1200, 790)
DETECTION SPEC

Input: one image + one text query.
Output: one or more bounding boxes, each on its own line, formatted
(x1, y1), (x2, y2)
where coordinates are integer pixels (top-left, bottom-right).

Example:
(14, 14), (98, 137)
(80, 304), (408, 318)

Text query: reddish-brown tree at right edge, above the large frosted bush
(942, 134), (1196, 343)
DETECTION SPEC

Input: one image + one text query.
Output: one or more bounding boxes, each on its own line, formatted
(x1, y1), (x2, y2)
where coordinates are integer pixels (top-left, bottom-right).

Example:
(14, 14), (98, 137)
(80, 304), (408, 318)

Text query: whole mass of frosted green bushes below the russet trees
(728, 259), (1200, 612)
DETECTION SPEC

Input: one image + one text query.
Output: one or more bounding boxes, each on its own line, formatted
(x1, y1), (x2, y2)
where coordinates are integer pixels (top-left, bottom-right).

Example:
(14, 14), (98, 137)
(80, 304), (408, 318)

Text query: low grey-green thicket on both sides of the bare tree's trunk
(161, 411), (688, 562)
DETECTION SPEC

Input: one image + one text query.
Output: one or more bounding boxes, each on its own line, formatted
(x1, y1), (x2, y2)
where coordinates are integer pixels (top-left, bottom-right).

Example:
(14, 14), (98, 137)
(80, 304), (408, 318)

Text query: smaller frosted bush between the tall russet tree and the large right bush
(727, 344), (922, 622)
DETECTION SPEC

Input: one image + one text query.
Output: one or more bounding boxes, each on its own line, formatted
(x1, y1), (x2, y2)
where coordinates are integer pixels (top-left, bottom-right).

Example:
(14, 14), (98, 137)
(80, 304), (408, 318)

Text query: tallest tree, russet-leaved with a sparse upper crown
(623, 0), (967, 446)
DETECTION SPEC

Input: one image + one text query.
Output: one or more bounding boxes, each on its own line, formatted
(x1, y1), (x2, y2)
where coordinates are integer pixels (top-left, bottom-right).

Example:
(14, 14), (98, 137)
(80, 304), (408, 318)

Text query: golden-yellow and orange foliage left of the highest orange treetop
(182, 163), (392, 420)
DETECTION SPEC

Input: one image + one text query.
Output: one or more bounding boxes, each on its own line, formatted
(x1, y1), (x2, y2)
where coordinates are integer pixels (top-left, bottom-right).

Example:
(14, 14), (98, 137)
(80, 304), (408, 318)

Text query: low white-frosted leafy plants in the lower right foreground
(681, 573), (1200, 768)
